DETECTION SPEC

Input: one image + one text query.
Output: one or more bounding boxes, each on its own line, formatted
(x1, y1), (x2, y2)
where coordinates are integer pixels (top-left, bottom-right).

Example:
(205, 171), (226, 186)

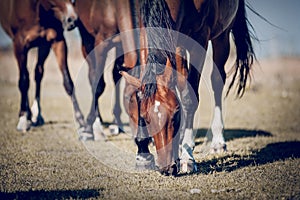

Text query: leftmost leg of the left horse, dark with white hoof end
(14, 41), (31, 131)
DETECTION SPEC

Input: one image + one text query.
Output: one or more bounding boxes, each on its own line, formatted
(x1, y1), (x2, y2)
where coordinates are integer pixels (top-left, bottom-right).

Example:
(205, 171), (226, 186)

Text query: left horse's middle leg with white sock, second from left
(31, 44), (50, 126)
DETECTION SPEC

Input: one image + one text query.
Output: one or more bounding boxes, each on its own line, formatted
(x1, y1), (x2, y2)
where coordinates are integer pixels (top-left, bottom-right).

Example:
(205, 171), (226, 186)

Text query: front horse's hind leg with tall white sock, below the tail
(210, 31), (230, 153)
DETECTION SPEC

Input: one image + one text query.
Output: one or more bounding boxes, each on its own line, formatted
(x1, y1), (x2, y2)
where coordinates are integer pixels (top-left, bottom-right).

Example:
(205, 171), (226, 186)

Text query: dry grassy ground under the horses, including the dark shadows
(0, 31), (300, 199)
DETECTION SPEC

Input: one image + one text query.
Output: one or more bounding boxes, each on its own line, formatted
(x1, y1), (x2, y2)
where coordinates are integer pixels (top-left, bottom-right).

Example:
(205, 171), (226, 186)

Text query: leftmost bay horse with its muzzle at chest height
(0, 0), (85, 131)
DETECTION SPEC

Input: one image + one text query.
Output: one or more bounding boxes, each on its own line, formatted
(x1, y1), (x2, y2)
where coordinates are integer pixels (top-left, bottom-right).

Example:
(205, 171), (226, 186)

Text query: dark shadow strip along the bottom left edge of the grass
(0, 189), (101, 199)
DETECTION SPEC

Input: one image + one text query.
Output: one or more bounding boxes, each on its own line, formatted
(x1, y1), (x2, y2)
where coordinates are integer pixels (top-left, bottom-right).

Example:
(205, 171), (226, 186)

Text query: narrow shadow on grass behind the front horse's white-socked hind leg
(195, 128), (273, 145)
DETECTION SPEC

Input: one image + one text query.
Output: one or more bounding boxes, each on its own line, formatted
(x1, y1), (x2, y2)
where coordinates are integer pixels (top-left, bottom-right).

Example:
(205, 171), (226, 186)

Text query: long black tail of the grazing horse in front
(226, 0), (256, 97)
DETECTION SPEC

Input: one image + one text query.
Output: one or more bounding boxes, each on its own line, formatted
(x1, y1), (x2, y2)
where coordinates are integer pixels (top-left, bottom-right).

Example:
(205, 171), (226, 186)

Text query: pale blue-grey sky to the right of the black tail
(247, 0), (300, 57)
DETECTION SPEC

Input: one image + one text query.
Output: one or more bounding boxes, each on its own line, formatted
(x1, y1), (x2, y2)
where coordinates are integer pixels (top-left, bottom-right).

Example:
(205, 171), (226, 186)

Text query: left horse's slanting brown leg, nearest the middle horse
(52, 39), (85, 127)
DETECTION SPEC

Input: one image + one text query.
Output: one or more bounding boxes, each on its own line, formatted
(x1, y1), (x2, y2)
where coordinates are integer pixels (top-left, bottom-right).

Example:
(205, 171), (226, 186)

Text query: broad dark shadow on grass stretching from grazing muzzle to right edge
(197, 141), (300, 174)
